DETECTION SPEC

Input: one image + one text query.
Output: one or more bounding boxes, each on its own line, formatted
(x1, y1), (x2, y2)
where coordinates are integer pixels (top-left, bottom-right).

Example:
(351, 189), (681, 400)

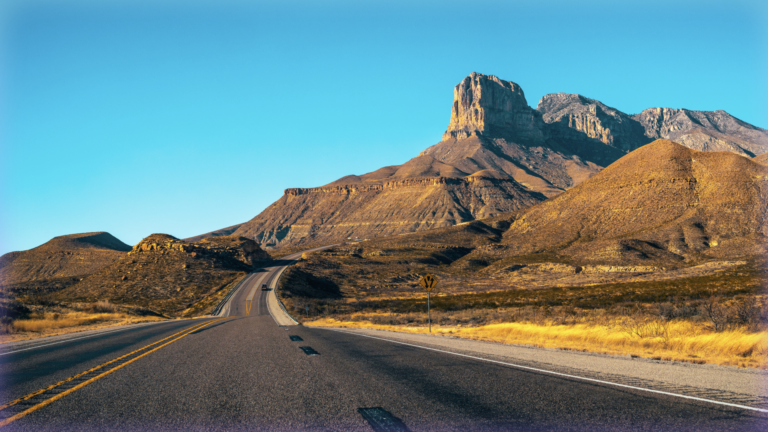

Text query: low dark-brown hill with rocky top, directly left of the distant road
(49, 234), (270, 316)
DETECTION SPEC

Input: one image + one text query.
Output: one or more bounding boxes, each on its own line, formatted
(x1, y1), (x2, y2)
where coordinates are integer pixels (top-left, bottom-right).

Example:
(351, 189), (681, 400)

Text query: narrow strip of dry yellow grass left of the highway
(0, 312), (164, 343)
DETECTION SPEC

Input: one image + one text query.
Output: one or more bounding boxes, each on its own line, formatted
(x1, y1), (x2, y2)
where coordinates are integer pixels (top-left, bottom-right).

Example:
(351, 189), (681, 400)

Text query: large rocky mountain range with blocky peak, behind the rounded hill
(233, 72), (768, 246)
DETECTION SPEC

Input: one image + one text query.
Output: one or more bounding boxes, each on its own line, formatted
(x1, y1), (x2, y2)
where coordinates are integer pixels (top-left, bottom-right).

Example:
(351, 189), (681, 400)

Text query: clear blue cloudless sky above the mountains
(0, 0), (768, 254)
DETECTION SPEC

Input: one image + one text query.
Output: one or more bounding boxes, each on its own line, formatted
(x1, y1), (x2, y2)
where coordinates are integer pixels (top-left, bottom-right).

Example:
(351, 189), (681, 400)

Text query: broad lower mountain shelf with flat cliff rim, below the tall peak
(235, 173), (545, 246)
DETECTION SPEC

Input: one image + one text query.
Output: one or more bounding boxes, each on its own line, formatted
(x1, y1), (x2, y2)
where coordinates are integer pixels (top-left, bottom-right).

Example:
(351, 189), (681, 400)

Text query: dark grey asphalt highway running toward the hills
(0, 250), (768, 431)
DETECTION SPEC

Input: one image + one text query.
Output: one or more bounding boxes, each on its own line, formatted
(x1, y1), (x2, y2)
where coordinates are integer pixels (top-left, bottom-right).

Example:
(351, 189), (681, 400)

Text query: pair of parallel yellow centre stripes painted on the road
(0, 318), (225, 428)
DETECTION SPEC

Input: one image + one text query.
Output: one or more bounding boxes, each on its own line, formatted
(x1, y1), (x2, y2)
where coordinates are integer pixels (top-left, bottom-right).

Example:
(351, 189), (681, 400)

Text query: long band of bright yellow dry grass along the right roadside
(304, 319), (768, 369)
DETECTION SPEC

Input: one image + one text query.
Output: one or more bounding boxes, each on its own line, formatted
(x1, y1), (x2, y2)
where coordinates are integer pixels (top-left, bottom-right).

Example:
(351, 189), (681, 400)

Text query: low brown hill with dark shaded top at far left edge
(0, 232), (131, 293)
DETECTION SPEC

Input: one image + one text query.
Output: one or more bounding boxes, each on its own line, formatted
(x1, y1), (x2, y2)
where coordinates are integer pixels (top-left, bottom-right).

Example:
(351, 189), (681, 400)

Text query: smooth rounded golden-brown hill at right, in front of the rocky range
(502, 140), (768, 265)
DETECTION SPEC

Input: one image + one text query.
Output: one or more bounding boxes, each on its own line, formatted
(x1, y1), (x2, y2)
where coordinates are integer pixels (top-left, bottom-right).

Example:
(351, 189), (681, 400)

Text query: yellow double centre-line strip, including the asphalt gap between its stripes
(0, 318), (224, 428)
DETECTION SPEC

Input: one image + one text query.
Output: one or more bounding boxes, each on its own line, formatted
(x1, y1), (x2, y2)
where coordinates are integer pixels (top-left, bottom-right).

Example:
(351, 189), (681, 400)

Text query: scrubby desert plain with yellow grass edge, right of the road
(279, 238), (768, 368)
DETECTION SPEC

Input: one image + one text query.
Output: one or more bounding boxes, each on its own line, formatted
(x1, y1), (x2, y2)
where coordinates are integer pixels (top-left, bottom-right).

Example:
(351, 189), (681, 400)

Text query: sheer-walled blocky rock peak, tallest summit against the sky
(443, 72), (542, 141)
